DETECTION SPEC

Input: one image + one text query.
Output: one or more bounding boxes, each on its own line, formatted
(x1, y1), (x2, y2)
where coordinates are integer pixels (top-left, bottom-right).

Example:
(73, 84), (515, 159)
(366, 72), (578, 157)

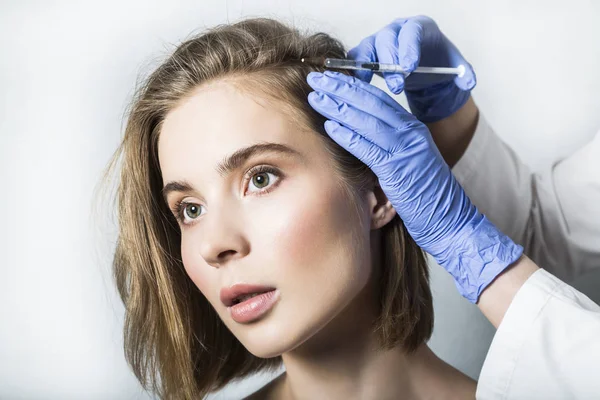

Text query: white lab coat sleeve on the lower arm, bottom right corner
(476, 269), (600, 400)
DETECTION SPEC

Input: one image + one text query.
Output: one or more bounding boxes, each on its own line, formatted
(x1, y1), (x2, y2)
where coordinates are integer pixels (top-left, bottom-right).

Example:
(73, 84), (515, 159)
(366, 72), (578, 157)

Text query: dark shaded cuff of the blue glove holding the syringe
(405, 81), (471, 123)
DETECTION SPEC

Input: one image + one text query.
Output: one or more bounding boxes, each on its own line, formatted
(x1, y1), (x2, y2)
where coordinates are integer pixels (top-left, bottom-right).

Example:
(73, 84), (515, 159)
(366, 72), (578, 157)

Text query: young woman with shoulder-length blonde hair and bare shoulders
(104, 19), (476, 399)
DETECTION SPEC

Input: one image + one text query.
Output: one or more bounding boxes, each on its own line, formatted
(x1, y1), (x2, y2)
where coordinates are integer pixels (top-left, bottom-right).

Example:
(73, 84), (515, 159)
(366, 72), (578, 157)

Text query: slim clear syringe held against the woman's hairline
(301, 58), (465, 78)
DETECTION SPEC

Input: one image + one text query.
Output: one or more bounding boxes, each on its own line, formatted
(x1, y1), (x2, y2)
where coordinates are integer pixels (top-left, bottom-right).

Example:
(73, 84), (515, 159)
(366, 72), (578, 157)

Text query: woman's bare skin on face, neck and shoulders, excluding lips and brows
(158, 80), (475, 399)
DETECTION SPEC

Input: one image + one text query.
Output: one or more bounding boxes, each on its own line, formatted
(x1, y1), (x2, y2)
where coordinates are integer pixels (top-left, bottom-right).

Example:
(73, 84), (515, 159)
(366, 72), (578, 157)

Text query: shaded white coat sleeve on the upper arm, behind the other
(452, 115), (600, 282)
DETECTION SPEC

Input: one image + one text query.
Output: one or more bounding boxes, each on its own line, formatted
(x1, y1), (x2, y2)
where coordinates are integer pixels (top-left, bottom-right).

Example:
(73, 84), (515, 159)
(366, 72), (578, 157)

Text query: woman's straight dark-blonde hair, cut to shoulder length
(107, 19), (433, 399)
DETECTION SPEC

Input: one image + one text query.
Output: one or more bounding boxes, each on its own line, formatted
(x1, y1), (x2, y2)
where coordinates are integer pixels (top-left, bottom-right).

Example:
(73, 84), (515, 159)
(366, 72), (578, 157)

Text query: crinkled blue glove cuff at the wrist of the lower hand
(432, 214), (523, 303)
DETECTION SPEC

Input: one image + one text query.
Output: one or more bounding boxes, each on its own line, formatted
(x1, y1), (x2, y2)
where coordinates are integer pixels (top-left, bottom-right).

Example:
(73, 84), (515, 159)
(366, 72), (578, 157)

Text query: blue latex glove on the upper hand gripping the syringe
(348, 16), (477, 122)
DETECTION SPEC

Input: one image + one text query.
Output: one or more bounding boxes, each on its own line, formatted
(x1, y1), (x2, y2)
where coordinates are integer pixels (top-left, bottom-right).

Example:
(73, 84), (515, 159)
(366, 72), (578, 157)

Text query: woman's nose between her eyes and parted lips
(200, 207), (250, 268)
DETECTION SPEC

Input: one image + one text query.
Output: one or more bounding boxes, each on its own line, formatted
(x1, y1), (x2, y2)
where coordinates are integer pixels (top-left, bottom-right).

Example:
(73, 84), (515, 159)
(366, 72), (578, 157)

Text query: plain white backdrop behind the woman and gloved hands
(0, 0), (600, 400)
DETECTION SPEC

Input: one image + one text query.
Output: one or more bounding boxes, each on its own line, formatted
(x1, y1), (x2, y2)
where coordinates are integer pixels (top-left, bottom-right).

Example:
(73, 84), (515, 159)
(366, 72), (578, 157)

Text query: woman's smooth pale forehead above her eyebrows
(158, 81), (321, 181)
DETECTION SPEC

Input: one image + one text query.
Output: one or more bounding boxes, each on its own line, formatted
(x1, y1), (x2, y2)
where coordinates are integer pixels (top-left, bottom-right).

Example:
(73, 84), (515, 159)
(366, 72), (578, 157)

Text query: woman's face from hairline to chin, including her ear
(158, 81), (382, 357)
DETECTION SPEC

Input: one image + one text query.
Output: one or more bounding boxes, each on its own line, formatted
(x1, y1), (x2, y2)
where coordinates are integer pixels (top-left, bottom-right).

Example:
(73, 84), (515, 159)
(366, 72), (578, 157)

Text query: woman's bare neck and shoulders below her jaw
(277, 268), (475, 400)
